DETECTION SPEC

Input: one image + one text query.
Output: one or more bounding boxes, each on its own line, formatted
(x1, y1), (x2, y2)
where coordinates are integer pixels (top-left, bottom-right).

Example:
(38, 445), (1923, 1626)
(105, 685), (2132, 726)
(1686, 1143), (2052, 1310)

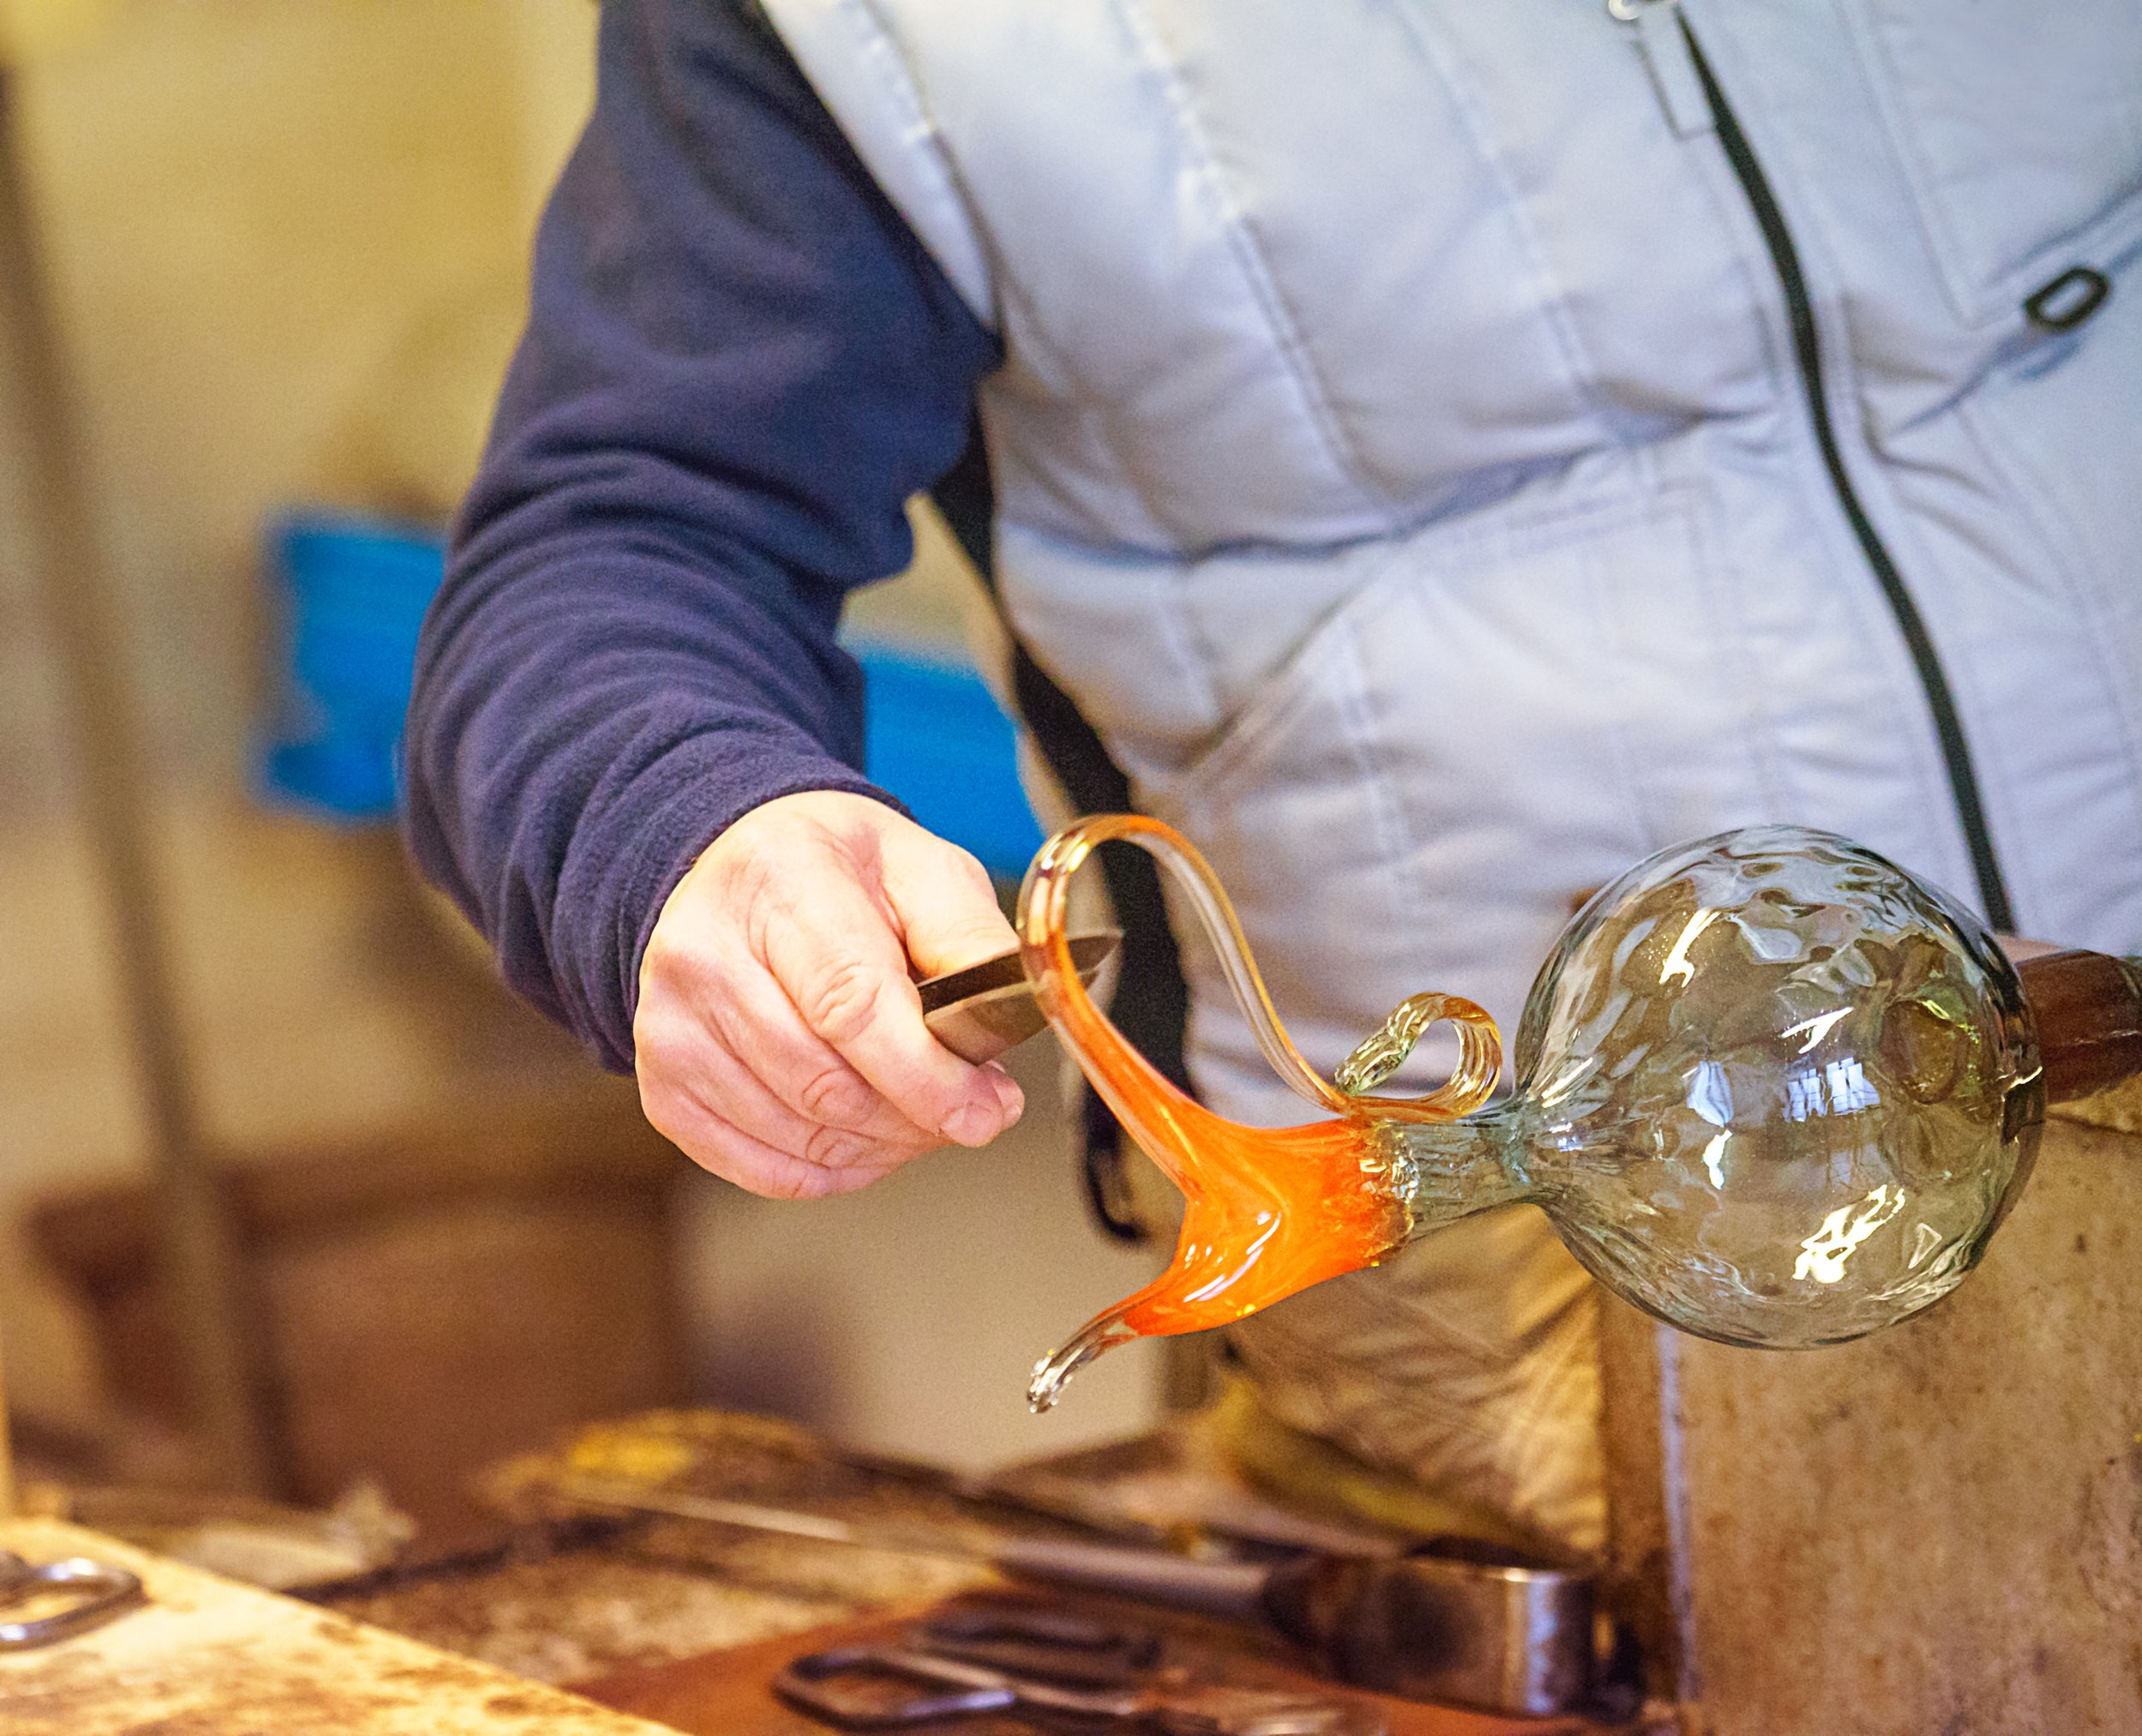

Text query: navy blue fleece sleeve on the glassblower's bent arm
(405, 0), (996, 1068)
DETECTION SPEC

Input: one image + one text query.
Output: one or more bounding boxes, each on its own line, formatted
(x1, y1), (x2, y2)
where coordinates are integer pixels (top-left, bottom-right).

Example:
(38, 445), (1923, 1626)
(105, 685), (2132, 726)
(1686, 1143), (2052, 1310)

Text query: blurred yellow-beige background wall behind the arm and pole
(0, 0), (1155, 1517)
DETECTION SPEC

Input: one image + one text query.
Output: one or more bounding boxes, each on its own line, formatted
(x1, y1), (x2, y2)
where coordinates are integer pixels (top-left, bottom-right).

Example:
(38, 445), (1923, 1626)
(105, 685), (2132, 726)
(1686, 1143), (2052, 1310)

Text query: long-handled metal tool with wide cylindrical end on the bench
(548, 1476), (1602, 1716)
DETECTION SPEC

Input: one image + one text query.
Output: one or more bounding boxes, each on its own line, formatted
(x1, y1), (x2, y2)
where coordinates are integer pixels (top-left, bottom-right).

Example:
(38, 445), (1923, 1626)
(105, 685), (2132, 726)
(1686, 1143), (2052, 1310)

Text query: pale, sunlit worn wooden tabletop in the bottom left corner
(0, 1519), (658, 1736)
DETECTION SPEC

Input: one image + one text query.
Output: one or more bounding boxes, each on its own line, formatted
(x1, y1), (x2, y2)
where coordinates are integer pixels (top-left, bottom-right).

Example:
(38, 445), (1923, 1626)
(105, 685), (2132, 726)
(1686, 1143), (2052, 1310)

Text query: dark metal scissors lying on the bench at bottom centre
(774, 1605), (1384, 1736)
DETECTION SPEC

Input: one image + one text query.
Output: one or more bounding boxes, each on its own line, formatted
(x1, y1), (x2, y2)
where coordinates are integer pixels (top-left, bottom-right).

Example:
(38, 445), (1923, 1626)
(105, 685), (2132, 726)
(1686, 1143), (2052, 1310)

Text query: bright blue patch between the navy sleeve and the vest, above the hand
(848, 643), (1041, 881)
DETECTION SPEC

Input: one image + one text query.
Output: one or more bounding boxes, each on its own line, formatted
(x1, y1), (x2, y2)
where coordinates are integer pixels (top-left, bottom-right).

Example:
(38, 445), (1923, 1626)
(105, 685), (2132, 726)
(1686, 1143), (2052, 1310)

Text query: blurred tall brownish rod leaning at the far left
(0, 67), (270, 1492)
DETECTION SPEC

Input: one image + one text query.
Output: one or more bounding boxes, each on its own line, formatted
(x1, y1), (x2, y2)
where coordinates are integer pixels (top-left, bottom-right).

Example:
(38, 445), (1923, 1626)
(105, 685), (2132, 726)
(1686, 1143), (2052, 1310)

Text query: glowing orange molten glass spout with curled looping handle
(1020, 814), (1502, 1410)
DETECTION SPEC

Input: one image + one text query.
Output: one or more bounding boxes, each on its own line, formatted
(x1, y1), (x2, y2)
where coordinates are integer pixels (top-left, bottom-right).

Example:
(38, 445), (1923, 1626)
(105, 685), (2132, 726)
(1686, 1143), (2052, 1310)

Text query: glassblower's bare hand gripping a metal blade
(632, 791), (1024, 1198)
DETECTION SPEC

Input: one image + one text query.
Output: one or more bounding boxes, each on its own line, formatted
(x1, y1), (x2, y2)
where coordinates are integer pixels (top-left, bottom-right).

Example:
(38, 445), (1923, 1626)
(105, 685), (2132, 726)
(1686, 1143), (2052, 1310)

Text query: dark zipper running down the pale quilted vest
(1606, 0), (2016, 935)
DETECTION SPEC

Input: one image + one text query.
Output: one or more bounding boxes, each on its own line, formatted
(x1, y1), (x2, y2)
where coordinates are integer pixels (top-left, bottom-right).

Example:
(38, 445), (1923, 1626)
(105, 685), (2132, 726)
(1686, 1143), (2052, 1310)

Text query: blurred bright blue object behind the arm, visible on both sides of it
(257, 512), (1041, 879)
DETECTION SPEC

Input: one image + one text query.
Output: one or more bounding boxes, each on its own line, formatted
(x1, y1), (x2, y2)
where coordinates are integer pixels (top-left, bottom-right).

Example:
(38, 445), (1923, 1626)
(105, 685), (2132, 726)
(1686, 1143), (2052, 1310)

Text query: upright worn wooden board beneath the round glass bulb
(1606, 1093), (2142, 1736)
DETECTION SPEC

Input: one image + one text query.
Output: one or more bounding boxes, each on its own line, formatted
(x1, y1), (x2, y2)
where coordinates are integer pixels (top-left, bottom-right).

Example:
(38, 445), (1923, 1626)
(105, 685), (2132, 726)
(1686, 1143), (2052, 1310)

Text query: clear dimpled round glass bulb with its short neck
(1405, 827), (2043, 1348)
